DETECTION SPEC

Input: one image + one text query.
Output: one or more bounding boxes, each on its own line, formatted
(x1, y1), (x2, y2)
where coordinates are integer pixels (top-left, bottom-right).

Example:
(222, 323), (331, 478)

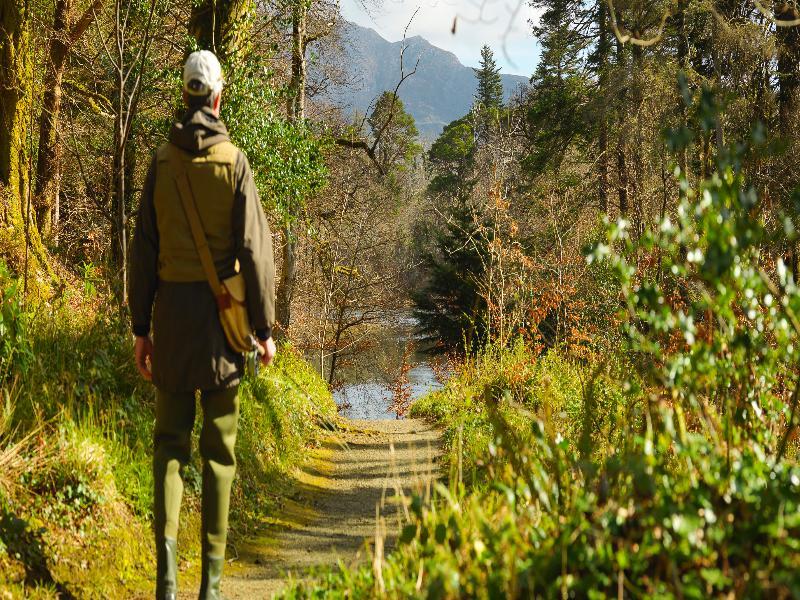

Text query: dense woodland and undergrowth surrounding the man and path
(0, 0), (800, 598)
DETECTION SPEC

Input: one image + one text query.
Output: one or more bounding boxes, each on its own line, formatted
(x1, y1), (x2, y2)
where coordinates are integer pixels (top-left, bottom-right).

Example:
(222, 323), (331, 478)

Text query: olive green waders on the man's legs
(153, 387), (239, 600)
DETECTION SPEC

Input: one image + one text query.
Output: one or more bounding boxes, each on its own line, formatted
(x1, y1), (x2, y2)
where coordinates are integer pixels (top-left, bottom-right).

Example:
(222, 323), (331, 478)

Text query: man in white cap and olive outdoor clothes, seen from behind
(128, 50), (275, 600)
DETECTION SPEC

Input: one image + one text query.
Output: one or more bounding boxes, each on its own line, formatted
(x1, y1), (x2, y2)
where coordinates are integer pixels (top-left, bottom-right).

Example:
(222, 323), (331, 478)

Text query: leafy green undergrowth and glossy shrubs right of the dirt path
(283, 85), (800, 599)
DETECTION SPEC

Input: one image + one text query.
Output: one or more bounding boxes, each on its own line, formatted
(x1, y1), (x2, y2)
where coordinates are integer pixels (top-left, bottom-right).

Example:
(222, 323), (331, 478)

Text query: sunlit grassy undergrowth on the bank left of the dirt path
(0, 263), (336, 598)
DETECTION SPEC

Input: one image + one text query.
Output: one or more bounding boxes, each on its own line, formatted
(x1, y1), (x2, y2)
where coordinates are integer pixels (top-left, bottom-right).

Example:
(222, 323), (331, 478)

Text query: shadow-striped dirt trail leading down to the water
(182, 419), (440, 600)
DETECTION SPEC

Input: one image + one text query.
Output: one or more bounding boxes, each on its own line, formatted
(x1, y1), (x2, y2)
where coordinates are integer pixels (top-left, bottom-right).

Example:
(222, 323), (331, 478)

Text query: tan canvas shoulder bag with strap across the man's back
(169, 144), (256, 352)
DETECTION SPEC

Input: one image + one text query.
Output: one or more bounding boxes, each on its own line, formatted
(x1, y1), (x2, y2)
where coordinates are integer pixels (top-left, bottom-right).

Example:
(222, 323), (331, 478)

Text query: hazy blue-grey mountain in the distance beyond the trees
(318, 21), (528, 141)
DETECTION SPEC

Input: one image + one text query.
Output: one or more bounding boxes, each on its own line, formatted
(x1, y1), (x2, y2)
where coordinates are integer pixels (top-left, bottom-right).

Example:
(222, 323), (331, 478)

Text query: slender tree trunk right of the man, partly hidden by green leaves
(276, 0), (308, 333)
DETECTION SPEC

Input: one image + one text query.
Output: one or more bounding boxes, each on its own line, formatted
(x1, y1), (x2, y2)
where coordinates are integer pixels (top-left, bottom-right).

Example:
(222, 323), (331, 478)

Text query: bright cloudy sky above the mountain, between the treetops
(341, 0), (539, 77)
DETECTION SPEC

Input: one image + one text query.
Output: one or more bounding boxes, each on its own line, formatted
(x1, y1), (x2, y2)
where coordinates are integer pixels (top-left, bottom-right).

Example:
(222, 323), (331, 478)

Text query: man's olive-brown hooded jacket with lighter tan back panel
(128, 108), (275, 392)
